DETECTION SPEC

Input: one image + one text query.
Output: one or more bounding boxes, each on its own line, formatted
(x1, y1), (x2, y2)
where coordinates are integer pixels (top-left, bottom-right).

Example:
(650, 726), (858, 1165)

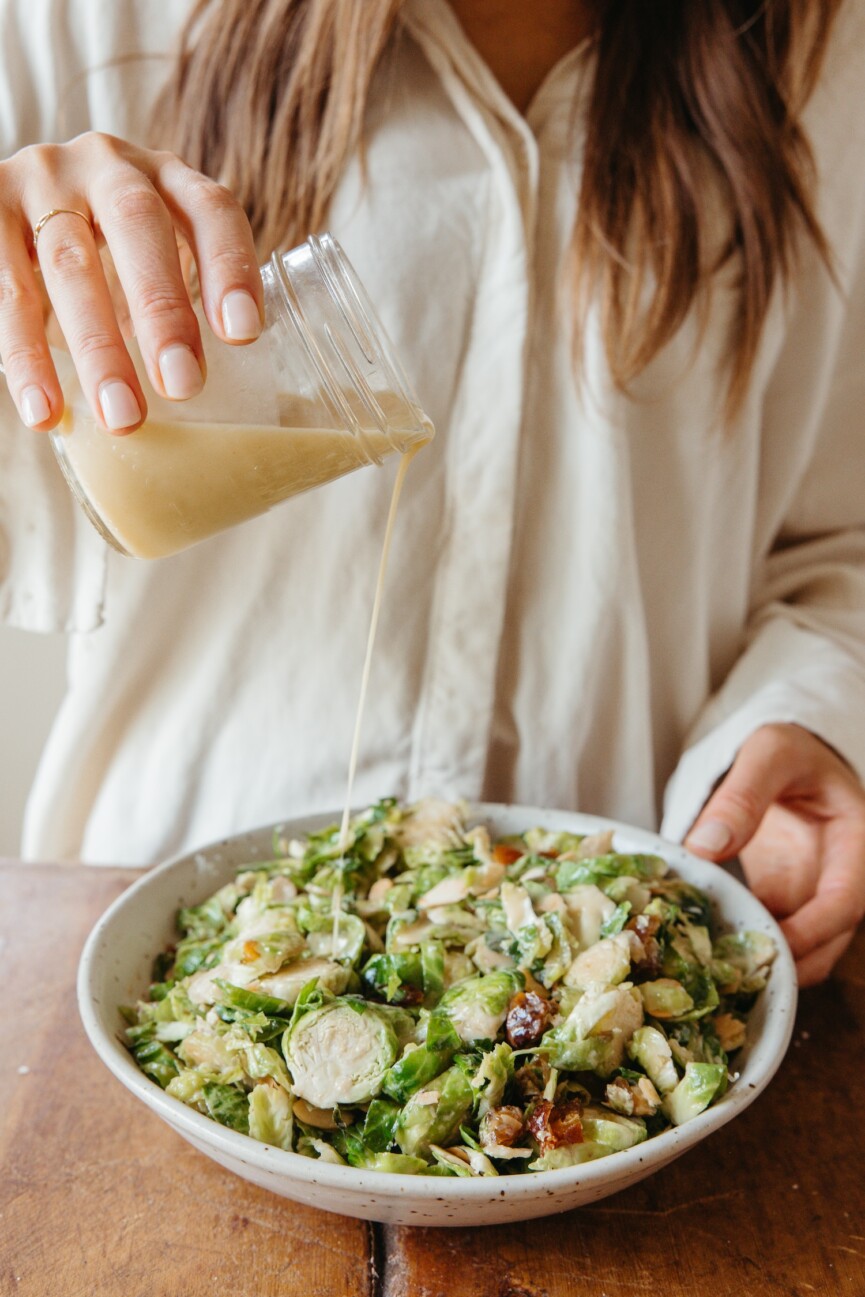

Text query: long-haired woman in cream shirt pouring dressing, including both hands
(0, 0), (865, 982)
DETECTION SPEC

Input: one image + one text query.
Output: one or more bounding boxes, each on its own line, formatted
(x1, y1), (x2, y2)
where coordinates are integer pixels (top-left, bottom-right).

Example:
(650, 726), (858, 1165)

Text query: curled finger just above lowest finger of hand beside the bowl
(781, 818), (865, 958)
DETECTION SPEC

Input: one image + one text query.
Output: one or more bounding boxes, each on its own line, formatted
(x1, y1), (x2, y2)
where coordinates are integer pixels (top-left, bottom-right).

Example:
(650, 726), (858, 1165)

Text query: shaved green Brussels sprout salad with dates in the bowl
(122, 799), (776, 1176)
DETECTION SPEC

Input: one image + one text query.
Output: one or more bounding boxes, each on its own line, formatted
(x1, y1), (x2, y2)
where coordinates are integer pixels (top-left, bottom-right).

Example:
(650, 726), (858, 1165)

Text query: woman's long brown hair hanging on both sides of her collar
(156, 0), (842, 411)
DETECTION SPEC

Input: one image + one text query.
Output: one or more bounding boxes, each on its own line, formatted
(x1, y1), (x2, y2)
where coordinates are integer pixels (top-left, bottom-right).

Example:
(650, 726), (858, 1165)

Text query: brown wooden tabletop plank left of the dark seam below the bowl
(0, 865), (373, 1297)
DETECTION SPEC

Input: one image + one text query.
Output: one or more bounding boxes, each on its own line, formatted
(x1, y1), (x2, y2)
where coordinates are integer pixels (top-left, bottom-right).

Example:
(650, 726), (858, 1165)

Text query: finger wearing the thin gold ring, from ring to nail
(36, 197), (147, 432)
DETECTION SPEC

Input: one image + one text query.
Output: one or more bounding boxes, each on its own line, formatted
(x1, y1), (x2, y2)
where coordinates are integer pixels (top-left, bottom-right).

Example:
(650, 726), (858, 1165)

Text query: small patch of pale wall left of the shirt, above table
(0, 626), (66, 856)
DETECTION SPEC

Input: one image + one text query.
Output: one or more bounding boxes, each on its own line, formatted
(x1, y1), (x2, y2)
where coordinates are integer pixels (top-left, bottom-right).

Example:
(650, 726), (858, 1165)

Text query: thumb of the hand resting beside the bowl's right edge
(685, 726), (790, 860)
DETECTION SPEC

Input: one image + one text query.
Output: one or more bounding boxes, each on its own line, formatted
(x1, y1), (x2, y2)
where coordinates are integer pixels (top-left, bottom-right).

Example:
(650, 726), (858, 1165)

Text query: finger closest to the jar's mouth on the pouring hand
(153, 153), (265, 342)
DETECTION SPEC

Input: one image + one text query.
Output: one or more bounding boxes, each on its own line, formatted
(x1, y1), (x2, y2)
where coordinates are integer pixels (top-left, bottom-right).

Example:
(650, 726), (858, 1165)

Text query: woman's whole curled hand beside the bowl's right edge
(685, 725), (865, 986)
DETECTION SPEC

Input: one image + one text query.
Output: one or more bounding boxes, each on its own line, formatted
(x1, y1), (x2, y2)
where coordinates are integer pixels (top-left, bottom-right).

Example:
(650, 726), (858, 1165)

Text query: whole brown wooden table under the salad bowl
(0, 861), (865, 1297)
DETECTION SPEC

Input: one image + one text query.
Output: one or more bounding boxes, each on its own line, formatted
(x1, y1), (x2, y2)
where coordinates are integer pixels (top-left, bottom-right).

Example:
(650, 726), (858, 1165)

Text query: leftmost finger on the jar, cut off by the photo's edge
(0, 213), (64, 429)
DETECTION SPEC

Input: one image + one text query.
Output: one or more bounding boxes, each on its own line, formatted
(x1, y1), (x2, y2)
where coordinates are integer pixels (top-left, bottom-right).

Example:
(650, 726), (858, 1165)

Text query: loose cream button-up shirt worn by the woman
(0, 0), (865, 864)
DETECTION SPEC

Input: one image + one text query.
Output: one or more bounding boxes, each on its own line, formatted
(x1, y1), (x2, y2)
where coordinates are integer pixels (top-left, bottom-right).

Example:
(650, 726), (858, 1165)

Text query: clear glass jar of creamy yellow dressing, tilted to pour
(52, 235), (433, 558)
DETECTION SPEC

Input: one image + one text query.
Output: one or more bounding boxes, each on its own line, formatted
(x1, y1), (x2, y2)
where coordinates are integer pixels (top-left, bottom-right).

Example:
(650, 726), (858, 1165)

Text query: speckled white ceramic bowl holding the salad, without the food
(78, 804), (796, 1226)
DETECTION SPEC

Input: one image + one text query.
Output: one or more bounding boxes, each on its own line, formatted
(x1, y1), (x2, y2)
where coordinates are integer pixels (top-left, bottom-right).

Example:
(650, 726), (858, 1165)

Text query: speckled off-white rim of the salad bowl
(78, 803), (798, 1206)
